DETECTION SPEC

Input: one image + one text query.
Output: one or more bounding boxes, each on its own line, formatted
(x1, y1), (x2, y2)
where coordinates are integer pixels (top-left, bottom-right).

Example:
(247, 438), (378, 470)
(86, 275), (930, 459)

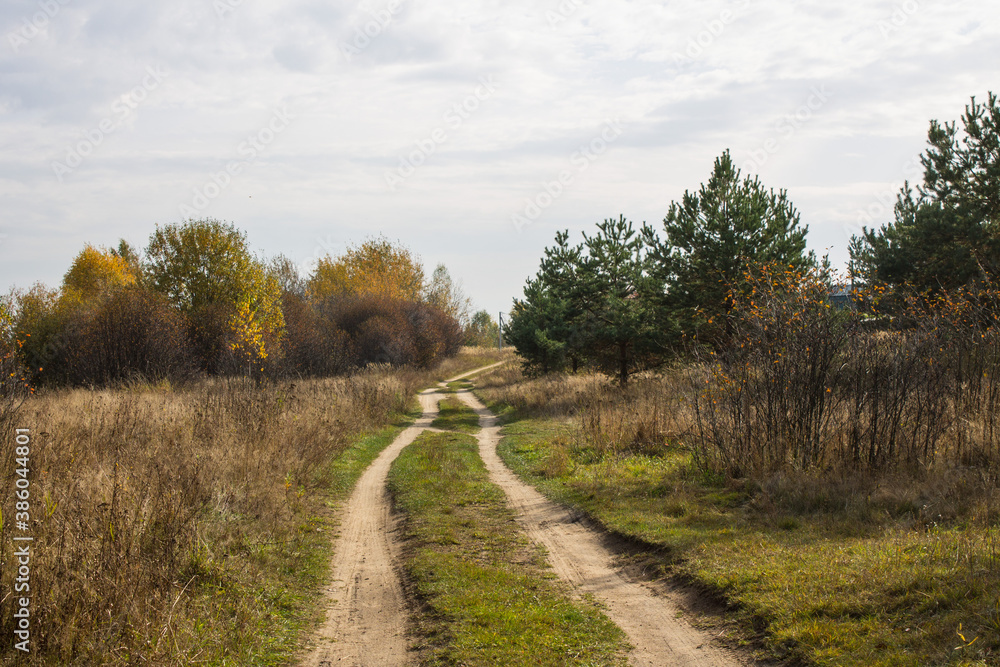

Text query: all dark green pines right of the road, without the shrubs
(505, 93), (1000, 385)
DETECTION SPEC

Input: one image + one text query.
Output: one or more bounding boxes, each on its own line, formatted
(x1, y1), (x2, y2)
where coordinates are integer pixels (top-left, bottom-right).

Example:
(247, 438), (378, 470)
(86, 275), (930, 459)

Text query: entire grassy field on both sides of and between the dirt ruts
(0, 336), (1000, 666)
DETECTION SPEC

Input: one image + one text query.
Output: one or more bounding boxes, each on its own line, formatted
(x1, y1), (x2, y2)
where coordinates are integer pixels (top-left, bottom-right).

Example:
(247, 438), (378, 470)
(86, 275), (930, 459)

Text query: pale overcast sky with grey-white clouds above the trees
(0, 0), (1000, 312)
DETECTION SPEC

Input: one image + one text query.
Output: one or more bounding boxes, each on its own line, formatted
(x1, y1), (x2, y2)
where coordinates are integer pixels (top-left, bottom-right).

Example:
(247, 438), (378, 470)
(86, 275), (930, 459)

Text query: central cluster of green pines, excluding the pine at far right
(505, 151), (816, 385)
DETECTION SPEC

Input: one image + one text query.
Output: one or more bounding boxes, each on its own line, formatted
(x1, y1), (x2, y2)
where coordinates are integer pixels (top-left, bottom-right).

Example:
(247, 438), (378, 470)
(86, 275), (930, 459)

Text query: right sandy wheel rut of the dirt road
(459, 391), (748, 667)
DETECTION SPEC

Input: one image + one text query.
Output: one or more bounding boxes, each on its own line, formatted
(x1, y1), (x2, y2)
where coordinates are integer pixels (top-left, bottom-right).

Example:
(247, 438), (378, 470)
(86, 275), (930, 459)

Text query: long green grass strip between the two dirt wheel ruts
(389, 433), (626, 666)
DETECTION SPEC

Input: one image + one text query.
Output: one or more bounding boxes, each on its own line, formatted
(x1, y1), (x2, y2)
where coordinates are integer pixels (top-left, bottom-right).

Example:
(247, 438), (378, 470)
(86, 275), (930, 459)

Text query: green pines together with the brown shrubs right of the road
(505, 94), (1000, 478)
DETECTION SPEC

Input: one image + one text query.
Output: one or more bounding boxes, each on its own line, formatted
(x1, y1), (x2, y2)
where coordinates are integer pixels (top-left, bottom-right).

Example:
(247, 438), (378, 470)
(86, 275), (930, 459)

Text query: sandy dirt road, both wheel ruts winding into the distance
(301, 364), (749, 667)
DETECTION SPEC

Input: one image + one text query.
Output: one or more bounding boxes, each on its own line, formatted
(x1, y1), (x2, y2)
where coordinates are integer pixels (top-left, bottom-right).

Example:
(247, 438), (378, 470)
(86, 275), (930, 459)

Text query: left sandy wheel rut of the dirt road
(301, 364), (498, 667)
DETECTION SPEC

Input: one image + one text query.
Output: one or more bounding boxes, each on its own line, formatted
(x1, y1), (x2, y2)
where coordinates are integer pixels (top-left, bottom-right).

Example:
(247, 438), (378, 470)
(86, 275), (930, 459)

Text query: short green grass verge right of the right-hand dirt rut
(499, 419), (1000, 667)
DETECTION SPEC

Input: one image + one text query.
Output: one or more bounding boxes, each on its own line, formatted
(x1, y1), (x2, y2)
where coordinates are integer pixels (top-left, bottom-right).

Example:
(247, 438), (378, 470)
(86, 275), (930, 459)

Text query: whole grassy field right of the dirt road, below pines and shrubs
(477, 366), (1000, 666)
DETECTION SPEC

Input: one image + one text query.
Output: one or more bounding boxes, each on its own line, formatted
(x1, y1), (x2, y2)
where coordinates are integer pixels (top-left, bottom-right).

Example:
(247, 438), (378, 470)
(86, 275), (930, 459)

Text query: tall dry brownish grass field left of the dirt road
(0, 352), (508, 665)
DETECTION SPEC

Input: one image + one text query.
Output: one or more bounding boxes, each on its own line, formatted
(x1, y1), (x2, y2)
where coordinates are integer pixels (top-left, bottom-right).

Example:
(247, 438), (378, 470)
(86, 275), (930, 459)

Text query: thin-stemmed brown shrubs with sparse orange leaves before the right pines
(692, 265), (1000, 477)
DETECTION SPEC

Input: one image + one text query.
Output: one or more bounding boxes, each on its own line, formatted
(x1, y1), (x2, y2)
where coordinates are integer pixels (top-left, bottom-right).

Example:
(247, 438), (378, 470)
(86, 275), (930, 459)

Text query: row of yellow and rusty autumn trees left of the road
(0, 219), (496, 385)
